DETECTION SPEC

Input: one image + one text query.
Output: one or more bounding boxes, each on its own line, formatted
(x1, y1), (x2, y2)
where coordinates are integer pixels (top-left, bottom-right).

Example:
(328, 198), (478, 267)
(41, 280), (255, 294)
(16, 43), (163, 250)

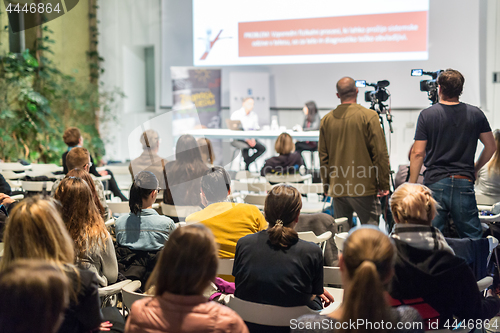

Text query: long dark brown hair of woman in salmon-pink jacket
(146, 224), (218, 296)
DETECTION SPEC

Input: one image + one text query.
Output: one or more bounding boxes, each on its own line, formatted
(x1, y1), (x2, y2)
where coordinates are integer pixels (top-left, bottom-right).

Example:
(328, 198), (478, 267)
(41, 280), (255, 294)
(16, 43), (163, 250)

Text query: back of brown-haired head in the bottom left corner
(0, 260), (70, 333)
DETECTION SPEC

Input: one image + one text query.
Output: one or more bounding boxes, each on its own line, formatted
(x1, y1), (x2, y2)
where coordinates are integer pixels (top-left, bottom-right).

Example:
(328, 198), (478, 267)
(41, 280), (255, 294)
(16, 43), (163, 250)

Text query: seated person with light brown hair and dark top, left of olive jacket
(260, 133), (304, 176)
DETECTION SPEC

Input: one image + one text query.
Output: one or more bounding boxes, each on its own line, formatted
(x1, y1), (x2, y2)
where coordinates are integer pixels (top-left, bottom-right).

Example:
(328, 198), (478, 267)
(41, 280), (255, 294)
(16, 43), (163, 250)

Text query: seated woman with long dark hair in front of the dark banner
(163, 135), (208, 206)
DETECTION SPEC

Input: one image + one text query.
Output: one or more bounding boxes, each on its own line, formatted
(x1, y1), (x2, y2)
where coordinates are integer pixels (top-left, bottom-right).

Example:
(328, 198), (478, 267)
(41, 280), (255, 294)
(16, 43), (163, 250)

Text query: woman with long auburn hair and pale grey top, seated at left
(54, 177), (118, 287)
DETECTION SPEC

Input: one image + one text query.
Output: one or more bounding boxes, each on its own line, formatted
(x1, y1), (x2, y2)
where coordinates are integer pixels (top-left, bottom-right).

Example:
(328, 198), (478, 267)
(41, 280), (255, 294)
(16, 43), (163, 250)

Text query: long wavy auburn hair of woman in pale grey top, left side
(54, 176), (109, 259)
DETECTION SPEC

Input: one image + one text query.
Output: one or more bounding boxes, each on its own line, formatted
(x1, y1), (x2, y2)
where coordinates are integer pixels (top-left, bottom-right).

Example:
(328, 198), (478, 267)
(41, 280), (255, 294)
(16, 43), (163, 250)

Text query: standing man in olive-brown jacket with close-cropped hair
(318, 77), (389, 226)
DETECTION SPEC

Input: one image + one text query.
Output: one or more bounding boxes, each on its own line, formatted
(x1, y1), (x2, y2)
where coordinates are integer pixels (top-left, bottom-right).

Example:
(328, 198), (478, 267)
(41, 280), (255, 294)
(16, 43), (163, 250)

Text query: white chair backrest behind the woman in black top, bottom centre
(227, 297), (317, 326)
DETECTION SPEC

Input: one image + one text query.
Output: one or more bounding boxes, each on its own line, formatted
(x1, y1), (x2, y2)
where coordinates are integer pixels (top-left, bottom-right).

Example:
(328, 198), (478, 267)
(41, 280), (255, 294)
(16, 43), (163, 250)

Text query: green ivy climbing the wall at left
(0, 6), (124, 164)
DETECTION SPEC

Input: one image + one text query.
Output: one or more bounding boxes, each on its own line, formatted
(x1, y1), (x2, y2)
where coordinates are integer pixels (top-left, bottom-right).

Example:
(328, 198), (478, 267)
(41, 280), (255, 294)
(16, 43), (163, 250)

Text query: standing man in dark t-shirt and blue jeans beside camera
(410, 69), (496, 238)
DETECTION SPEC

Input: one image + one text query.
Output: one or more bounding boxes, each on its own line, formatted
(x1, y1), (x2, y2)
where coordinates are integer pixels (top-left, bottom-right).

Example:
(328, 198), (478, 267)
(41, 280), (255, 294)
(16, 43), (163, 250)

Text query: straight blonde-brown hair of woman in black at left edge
(0, 196), (75, 270)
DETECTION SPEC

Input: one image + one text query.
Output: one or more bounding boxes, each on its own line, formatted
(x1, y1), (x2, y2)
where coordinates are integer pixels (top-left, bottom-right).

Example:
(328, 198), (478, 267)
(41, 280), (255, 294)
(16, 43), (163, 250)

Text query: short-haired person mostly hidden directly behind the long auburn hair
(50, 147), (111, 221)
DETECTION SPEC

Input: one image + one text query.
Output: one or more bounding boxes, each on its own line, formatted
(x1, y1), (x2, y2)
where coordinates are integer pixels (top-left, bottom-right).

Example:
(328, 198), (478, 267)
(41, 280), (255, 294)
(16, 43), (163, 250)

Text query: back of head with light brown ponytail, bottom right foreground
(340, 228), (395, 333)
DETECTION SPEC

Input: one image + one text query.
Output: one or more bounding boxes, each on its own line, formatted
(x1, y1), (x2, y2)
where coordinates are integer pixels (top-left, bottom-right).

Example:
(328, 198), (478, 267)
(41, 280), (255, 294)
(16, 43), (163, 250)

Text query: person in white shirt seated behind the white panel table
(231, 97), (266, 170)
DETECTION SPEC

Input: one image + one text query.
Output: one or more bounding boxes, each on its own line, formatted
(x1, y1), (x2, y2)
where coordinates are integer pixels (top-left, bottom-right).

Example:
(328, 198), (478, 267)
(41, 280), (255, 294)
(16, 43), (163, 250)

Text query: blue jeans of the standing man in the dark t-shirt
(427, 178), (482, 239)
